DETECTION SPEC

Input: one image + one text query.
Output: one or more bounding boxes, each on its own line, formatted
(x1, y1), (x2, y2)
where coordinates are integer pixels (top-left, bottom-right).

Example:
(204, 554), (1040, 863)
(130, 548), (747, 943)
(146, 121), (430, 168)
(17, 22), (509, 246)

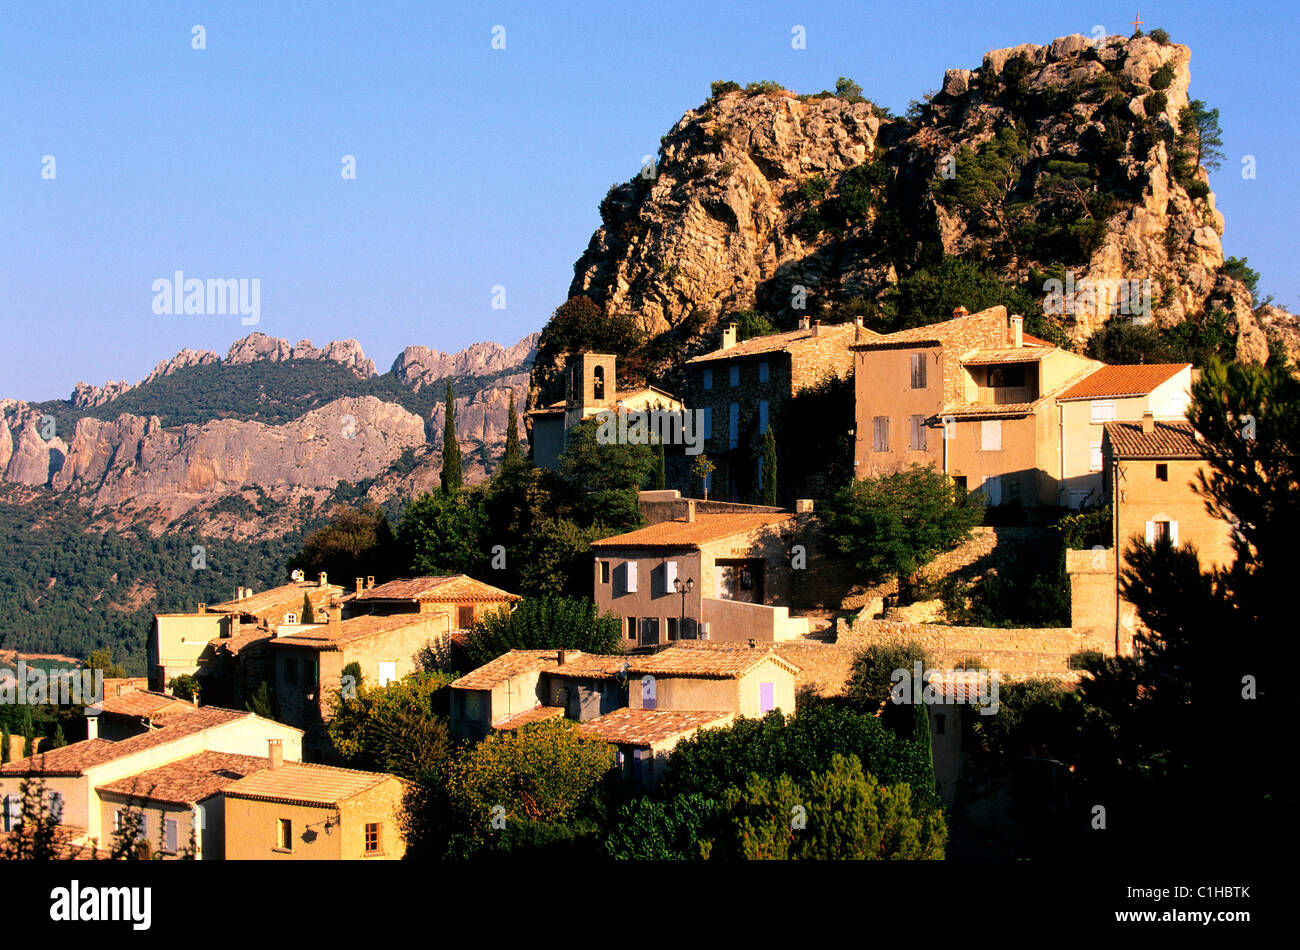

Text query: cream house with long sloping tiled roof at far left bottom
(0, 707), (303, 842)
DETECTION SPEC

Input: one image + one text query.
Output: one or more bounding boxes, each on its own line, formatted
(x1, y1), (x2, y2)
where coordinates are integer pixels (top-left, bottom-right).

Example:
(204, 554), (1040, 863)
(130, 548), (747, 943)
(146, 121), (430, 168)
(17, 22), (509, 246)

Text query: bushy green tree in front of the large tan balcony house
(826, 465), (983, 587)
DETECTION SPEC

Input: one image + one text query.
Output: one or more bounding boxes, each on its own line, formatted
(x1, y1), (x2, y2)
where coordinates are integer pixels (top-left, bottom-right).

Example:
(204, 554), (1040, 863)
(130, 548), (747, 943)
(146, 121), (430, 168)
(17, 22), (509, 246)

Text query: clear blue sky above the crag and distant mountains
(0, 0), (1300, 399)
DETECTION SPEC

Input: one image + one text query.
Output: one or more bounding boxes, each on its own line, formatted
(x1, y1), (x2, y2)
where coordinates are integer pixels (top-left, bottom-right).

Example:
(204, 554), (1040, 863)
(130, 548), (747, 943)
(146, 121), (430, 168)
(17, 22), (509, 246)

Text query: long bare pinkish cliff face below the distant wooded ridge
(43, 396), (424, 507)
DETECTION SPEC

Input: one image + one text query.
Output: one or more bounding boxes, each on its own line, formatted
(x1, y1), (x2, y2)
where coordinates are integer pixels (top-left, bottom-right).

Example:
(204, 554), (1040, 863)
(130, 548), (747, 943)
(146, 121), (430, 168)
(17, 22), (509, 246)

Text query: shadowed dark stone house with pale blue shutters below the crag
(685, 317), (878, 500)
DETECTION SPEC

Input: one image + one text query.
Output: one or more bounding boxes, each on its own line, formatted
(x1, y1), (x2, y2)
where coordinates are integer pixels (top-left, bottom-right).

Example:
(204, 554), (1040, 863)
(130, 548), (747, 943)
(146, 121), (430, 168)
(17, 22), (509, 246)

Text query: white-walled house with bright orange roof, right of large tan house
(1057, 363), (1192, 508)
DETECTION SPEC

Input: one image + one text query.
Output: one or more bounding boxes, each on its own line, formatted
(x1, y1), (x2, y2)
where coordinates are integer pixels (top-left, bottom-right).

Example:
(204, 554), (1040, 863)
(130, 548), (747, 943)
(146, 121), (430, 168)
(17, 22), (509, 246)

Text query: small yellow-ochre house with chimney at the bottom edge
(222, 746), (406, 860)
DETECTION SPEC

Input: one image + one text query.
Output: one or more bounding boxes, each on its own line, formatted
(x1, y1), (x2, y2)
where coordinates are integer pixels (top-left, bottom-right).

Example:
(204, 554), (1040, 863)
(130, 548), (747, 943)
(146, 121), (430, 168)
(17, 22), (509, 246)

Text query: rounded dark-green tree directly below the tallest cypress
(398, 491), (486, 576)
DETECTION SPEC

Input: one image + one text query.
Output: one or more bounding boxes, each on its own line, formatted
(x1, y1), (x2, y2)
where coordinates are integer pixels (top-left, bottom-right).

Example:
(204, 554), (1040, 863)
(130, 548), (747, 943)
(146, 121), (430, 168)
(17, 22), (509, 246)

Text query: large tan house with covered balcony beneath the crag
(852, 307), (1101, 507)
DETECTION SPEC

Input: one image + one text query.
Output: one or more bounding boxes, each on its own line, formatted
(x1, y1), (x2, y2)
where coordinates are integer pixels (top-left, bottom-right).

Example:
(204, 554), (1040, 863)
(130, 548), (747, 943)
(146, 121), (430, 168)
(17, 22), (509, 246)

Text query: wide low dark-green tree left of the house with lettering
(465, 597), (623, 667)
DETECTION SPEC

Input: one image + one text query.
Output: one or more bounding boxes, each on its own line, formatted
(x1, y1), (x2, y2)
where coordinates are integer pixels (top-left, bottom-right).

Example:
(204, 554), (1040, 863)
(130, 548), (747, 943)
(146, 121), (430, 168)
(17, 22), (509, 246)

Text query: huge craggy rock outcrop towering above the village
(559, 35), (1286, 382)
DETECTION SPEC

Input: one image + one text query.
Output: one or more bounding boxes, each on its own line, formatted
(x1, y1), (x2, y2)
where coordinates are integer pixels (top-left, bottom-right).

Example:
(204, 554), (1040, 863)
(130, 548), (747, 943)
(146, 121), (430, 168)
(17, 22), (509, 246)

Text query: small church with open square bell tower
(524, 352), (683, 470)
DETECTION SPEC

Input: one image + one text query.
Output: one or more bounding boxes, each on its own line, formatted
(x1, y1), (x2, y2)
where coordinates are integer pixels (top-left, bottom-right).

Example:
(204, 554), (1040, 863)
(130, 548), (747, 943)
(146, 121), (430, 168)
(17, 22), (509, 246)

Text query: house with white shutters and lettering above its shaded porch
(592, 499), (811, 648)
